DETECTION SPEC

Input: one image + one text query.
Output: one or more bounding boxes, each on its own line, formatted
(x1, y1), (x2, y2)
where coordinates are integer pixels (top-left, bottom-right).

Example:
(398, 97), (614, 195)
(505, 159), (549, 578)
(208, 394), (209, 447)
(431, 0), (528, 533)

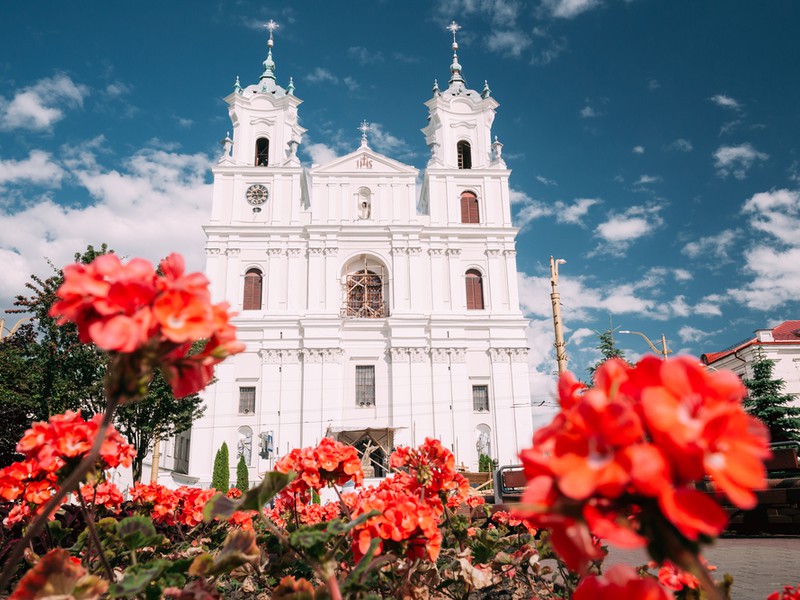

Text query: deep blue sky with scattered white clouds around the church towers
(0, 0), (800, 397)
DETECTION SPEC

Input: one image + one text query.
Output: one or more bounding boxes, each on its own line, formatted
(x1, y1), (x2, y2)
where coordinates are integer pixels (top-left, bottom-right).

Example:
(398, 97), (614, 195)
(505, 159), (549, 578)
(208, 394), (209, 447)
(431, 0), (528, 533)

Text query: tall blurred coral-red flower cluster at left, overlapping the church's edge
(50, 254), (244, 397)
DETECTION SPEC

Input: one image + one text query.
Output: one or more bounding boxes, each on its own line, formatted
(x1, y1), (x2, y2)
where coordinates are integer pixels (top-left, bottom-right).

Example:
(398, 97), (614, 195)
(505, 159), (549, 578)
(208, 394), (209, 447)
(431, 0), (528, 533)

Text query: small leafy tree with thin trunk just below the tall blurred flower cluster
(115, 370), (205, 482)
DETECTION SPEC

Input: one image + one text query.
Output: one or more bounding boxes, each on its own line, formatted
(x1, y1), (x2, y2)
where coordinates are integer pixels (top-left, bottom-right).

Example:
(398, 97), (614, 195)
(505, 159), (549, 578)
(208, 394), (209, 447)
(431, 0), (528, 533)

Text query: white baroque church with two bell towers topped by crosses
(188, 22), (533, 485)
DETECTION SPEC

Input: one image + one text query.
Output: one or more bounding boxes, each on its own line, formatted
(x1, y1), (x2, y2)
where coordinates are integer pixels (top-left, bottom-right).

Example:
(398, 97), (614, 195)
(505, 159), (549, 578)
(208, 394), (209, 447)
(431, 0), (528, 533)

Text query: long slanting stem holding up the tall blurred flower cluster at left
(0, 395), (119, 591)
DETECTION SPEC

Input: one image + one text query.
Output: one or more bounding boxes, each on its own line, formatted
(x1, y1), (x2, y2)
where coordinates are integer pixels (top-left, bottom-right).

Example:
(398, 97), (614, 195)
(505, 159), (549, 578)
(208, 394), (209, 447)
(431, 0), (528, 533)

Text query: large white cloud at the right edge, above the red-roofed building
(728, 189), (800, 310)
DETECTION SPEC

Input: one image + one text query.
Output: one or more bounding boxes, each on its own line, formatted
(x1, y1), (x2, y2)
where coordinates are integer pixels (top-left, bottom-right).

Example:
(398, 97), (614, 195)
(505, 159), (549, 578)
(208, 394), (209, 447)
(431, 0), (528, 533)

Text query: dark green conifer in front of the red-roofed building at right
(742, 348), (800, 442)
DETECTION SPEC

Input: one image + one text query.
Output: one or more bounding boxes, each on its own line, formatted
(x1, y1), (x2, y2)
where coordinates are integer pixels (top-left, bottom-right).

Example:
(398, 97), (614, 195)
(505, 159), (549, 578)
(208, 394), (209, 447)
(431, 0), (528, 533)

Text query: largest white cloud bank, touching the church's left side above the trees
(0, 141), (212, 305)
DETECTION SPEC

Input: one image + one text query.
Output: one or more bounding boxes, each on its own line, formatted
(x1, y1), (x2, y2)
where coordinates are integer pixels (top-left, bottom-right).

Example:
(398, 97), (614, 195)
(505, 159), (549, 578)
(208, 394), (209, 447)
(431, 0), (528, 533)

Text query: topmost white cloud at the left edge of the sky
(0, 74), (89, 131)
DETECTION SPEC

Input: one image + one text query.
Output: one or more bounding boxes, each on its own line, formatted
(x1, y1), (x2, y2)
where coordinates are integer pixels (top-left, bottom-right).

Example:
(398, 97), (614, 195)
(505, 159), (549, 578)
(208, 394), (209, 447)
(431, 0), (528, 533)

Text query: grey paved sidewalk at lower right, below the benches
(605, 536), (800, 600)
